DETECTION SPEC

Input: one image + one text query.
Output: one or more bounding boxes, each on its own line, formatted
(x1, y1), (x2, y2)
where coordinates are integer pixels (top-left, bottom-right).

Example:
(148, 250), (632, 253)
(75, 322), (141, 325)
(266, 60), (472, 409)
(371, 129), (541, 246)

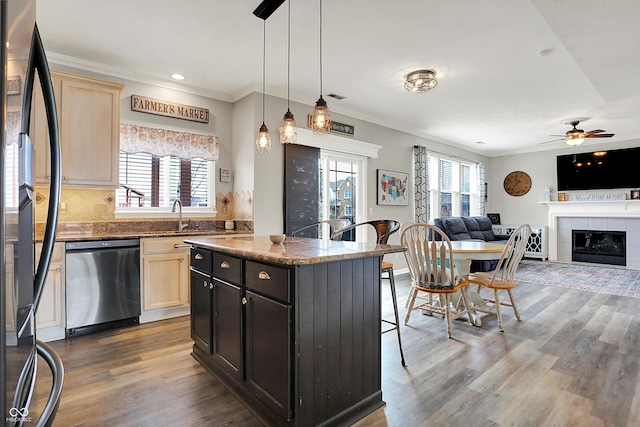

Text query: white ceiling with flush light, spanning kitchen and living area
(37, 0), (640, 156)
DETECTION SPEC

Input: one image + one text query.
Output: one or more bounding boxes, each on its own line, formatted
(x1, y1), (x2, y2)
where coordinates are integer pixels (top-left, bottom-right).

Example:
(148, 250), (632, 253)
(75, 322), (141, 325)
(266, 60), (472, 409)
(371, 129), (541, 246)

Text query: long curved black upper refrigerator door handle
(21, 24), (61, 312)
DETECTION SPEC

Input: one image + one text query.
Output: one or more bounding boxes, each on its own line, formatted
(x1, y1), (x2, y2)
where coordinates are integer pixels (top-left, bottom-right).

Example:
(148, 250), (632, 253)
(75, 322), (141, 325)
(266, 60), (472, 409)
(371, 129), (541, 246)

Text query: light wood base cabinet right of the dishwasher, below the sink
(140, 237), (189, 322)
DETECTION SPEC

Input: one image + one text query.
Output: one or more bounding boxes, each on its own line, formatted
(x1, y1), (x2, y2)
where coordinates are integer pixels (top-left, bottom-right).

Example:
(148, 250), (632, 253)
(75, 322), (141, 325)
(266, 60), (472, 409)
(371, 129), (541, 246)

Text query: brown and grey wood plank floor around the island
(36, 276), (640, 427)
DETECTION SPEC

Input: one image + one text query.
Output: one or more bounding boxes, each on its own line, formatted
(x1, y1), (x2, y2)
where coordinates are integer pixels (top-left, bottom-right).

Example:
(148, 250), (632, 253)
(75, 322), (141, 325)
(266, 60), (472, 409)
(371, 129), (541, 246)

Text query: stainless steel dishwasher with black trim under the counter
(65, 239), (140, 337)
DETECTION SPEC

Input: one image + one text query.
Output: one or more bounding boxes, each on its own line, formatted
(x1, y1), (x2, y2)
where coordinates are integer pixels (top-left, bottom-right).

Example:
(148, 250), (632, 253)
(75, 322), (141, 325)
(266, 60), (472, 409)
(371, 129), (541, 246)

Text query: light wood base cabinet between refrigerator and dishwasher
(35, 243), (66, 341)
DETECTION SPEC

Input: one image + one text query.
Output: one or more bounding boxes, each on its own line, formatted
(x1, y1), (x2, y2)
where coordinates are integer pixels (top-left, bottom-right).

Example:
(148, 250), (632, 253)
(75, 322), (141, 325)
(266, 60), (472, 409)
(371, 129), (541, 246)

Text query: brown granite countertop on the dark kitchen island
(185, 236), (406, 265)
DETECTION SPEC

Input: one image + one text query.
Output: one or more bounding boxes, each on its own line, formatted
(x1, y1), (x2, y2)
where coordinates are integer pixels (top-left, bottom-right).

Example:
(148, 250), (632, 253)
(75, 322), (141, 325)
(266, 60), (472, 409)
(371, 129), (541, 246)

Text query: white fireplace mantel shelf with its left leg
(539, 200), (640, 261)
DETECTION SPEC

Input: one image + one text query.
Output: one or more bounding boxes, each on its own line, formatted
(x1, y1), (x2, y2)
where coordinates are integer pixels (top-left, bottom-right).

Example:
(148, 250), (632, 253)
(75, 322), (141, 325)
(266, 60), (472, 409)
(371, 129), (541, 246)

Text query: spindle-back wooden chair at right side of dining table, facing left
(463, 224), (531, 332)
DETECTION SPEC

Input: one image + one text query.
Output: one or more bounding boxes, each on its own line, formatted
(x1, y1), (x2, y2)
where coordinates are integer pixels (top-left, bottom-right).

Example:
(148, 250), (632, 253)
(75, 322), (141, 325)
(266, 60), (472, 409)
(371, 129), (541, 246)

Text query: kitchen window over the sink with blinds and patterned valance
(116, 124), (219, 212)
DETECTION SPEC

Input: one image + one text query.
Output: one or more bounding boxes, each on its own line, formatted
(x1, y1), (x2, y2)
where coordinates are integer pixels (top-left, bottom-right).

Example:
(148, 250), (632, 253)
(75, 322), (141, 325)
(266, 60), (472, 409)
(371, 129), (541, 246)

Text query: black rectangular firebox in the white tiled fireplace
(571, 230), (627, 266)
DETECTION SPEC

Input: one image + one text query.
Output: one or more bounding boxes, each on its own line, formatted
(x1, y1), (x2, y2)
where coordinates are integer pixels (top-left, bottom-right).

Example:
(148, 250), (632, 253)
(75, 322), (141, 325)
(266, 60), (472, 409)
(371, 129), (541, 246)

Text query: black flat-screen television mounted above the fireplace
(557, 147), (640, 191)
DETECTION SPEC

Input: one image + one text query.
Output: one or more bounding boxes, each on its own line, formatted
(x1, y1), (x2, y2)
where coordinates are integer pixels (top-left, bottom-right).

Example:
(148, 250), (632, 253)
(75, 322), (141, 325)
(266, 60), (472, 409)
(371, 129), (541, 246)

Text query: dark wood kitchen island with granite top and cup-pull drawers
(185, 236), (405, 426)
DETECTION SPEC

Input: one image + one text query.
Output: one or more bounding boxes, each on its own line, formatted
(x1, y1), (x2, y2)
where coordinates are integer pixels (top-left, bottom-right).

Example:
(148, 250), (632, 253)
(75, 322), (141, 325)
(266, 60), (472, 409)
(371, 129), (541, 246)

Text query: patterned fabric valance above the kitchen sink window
(120, 123), (220, 160)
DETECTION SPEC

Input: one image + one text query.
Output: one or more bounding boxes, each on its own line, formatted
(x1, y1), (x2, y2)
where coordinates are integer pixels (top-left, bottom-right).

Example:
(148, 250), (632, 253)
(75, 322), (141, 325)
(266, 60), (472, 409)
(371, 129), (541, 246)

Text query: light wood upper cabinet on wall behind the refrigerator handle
(31, 72), (124, 188)
